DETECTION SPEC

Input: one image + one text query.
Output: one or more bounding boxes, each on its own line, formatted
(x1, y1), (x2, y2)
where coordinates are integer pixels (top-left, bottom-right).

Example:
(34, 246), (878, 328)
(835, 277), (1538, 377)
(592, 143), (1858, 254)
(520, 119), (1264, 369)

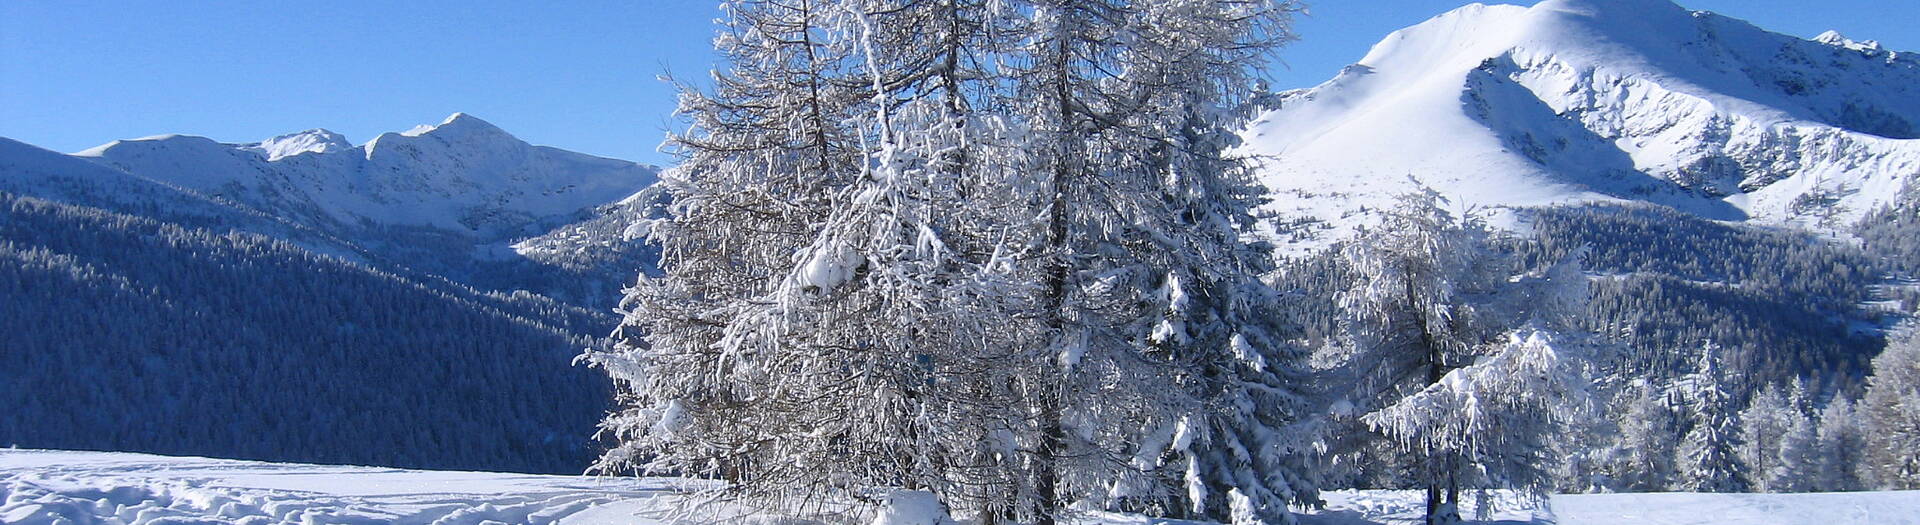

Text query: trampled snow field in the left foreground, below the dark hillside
(0, 450), (672, 525)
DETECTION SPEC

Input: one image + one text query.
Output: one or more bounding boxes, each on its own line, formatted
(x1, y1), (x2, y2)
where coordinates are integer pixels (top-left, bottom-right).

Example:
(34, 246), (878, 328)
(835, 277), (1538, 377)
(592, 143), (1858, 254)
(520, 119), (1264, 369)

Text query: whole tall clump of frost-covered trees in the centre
(589, 0), (1315, 523)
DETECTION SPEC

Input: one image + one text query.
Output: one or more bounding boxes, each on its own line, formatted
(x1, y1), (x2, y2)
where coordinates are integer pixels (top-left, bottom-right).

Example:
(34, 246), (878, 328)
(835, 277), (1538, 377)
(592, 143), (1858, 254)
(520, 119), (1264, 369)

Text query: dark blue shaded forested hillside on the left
(0, 192), (609, 473)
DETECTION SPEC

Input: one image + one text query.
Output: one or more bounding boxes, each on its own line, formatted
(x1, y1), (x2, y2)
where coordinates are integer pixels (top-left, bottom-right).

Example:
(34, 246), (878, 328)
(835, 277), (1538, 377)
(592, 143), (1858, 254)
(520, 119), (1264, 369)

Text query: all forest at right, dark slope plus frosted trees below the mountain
(1271, 197), (1920, 492)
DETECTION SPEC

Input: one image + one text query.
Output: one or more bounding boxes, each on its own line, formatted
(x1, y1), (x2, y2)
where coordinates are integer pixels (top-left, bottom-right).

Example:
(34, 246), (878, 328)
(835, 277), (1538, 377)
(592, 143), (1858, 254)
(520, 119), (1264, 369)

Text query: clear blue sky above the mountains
(0, 0), (1920, 163)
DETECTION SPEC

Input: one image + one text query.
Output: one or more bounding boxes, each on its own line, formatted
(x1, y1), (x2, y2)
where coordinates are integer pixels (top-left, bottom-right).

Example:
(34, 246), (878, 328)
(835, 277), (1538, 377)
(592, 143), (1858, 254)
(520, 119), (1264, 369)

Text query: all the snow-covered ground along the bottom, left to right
(0, 450), (1920, 525)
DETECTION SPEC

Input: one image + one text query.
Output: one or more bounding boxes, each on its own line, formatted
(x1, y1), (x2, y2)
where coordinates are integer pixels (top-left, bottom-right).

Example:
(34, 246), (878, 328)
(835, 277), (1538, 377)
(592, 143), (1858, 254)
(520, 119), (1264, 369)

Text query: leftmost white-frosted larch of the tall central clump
(588, 0), (897, 511)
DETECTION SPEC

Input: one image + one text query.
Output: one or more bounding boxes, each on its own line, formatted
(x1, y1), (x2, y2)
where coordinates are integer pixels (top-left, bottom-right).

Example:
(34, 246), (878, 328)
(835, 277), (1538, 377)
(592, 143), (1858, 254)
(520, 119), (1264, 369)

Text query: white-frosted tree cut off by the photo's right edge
(1857, 327), (1920, 490)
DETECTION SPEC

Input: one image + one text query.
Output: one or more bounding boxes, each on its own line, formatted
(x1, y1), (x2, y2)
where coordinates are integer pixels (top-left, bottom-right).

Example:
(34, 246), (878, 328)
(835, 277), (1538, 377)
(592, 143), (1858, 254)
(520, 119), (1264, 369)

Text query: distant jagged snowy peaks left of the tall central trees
(77, 113), (659, 240)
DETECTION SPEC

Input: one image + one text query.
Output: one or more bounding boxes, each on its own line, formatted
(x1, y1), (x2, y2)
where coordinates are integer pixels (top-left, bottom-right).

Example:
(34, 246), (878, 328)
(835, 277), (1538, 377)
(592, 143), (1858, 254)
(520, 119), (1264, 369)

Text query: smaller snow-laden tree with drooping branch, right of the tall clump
(1329, 190), (1586, 523)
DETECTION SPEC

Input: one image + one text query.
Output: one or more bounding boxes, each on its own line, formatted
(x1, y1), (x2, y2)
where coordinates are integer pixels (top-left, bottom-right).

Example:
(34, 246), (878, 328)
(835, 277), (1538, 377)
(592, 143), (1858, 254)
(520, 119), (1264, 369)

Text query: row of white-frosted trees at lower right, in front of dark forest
(1561, 331), (1920, 492)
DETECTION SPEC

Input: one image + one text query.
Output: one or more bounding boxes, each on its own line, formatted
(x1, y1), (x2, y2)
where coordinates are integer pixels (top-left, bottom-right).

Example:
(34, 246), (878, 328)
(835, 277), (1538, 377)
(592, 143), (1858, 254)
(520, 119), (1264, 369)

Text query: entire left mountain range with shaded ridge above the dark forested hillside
(0, 113), (659, 310)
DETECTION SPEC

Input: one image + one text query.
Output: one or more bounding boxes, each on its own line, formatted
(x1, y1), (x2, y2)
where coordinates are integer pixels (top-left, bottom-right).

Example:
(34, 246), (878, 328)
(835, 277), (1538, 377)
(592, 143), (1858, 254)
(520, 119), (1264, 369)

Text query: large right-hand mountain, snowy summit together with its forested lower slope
(1242, 0), (1920, 400)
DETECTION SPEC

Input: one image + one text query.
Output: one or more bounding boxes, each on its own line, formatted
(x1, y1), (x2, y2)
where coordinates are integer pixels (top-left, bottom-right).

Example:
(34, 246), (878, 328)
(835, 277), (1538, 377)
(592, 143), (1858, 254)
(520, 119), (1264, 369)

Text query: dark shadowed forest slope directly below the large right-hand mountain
(1513, 204), (1891, 386)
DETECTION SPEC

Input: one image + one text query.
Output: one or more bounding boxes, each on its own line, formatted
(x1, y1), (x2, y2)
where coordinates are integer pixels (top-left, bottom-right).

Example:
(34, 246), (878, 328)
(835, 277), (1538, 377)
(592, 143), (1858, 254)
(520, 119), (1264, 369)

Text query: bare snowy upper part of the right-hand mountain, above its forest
(1246, 0), (1920, 246)
